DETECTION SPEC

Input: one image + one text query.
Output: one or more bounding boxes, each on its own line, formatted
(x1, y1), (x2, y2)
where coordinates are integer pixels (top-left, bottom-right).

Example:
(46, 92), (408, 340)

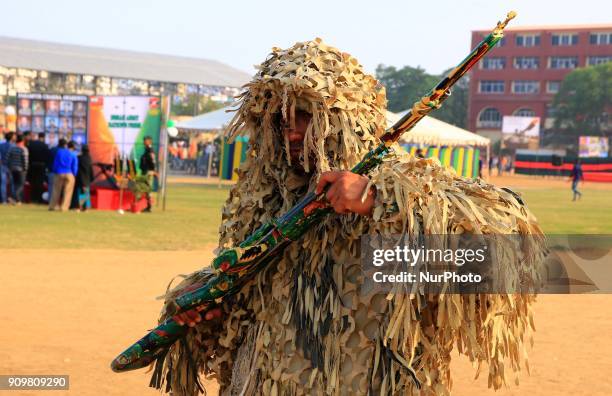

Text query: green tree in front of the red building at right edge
(553, 62), (612, 135)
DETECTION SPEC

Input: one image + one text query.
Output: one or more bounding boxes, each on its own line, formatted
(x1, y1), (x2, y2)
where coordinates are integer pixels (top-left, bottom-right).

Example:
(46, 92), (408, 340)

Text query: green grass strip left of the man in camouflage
(0, 184), (229, 250)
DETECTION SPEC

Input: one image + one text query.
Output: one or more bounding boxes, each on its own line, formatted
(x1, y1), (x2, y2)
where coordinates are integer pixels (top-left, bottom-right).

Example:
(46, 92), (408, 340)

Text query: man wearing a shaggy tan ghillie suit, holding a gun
(160, 39), (542, 395)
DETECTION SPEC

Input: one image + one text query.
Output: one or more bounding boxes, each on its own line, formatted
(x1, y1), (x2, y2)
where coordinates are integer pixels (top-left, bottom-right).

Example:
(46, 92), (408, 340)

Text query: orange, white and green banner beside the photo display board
(89, 96), (161, 169)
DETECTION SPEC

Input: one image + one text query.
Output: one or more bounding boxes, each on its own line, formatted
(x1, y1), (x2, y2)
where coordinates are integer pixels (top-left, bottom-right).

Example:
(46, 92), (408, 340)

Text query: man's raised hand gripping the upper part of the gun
(316, 171), (376, 216)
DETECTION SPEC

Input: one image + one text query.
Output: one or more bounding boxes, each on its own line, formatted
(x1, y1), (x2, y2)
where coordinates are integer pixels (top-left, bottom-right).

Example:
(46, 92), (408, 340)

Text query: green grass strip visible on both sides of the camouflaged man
(0, 184), (612, 250)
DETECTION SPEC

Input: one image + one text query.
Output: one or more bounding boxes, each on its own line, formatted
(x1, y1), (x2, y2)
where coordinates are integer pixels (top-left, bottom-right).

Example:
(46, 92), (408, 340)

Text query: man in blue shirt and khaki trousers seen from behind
(49, 141), (78, 212)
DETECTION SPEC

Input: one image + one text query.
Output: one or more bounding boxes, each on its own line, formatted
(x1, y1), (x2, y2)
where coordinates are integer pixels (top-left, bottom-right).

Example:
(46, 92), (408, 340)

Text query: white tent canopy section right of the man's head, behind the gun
(387, 111), (491, 147)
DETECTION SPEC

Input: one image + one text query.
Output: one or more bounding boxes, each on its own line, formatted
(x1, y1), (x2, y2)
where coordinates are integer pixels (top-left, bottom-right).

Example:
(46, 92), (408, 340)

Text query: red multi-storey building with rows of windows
(468, 24), (612, 144)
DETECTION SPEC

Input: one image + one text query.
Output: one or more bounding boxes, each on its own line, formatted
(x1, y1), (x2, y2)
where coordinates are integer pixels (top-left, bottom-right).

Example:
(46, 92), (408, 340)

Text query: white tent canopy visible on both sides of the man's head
(176, 106), (490, 147)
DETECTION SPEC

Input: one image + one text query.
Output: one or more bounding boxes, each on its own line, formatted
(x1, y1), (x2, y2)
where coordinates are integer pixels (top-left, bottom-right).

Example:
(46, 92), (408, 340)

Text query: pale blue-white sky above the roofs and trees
(0, 0), (612, 74)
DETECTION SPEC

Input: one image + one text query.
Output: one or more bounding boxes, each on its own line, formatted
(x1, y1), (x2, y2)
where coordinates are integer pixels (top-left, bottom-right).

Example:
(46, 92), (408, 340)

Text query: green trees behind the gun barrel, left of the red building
(376, 65), (469, 128)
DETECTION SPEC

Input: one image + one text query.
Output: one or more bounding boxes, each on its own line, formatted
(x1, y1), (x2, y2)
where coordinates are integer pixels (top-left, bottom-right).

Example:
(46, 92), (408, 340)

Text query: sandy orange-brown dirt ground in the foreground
(0, 246), (612, 396)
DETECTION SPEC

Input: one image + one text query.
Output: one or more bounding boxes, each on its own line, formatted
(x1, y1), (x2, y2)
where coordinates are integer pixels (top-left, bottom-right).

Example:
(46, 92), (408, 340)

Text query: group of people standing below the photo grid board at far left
(0, 132), (93, 211)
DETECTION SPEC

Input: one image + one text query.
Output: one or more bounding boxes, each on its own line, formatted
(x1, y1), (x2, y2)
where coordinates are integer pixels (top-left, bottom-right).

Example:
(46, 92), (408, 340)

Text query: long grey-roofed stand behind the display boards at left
(0, 37), (250, 109)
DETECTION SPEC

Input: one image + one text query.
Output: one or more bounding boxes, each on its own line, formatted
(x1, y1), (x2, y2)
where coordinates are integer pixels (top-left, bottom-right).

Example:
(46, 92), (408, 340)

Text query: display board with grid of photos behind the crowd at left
(17, 93), (88, 146)
